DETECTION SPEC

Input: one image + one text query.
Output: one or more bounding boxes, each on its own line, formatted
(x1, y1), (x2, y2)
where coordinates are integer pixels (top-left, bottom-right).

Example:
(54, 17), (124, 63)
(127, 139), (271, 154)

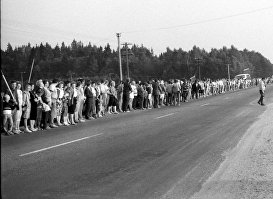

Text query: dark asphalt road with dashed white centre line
(1, 85), (273, 199)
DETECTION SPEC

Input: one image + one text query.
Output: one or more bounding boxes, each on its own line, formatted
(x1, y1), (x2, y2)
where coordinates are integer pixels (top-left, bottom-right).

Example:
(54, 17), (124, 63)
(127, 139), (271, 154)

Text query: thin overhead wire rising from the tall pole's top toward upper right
(122, 6), (273, 34)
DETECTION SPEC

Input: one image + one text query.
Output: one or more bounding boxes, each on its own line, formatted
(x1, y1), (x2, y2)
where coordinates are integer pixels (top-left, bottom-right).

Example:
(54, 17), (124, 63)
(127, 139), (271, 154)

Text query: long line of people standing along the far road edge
(1, 78), (270, 135)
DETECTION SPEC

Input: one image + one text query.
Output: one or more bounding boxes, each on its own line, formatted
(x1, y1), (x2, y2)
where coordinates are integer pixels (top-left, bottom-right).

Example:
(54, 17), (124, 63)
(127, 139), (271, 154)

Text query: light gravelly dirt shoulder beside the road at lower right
(191, 100), (273, 199)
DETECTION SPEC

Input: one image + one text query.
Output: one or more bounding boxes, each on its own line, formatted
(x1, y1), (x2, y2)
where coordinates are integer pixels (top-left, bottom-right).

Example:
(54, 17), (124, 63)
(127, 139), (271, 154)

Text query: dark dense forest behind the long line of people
(1, 40), (273, 84)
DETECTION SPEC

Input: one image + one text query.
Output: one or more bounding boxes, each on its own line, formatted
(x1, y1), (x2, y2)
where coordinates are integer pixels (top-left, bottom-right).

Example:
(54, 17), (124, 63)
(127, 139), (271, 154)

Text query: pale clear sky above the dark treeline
(1, 0), (273, 63)
